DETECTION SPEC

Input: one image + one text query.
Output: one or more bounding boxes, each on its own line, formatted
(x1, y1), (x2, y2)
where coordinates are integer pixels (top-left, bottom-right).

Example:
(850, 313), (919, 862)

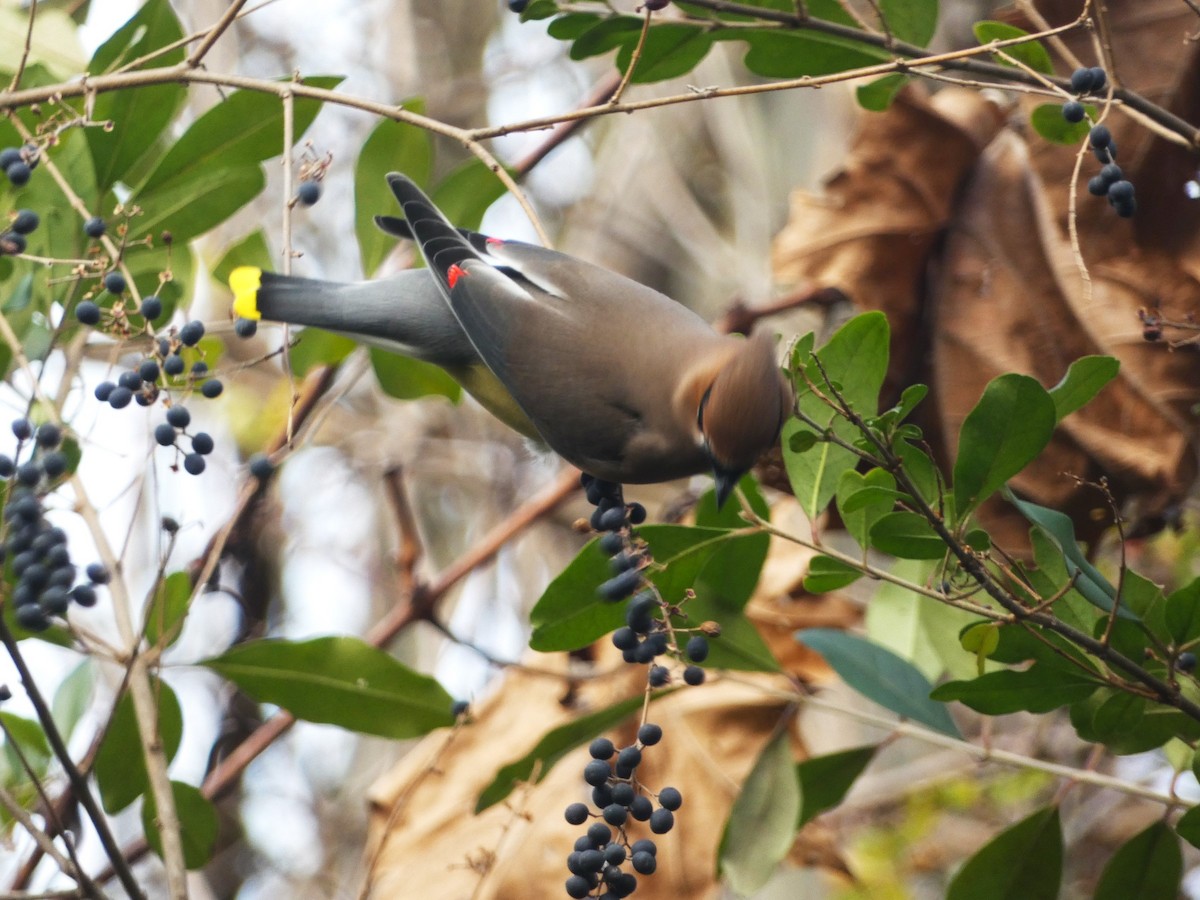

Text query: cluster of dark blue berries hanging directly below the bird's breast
(582, 474), (705, 688)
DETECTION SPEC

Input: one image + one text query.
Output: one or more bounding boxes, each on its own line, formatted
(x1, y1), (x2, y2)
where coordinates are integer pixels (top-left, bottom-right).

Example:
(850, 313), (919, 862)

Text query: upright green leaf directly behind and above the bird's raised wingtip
(354, 107), (433, 278)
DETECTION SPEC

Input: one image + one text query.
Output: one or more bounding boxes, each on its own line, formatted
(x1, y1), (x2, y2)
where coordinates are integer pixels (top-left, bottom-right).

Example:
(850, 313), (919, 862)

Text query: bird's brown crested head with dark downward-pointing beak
(696, 331), (792, 506)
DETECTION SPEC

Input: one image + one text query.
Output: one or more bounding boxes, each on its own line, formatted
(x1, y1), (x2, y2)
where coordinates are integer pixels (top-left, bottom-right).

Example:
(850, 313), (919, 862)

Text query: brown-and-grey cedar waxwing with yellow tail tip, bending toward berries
(229, 173), (792, 503)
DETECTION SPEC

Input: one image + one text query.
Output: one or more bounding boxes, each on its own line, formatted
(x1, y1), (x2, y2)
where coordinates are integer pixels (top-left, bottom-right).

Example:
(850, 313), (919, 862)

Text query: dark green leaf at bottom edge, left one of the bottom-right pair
(946, 806), (1062, 900)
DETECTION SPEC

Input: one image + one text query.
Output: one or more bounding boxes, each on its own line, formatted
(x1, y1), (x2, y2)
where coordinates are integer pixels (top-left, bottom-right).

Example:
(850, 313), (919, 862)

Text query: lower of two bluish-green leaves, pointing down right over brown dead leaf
(796, 628), (961, 738)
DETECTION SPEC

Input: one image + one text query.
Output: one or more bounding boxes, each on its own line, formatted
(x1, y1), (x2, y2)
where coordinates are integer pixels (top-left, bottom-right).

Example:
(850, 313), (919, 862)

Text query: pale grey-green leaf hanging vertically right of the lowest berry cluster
(718, 728), (800, 895)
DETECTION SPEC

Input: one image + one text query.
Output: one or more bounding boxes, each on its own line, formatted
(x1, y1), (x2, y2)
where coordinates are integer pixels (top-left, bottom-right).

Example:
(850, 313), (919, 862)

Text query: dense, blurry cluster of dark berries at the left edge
(0, 419), (109, 631)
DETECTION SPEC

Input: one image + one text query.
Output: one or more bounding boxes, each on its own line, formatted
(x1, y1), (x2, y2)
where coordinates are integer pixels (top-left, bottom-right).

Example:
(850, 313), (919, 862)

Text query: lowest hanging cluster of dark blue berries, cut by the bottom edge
(564, 722), (683, 900)
